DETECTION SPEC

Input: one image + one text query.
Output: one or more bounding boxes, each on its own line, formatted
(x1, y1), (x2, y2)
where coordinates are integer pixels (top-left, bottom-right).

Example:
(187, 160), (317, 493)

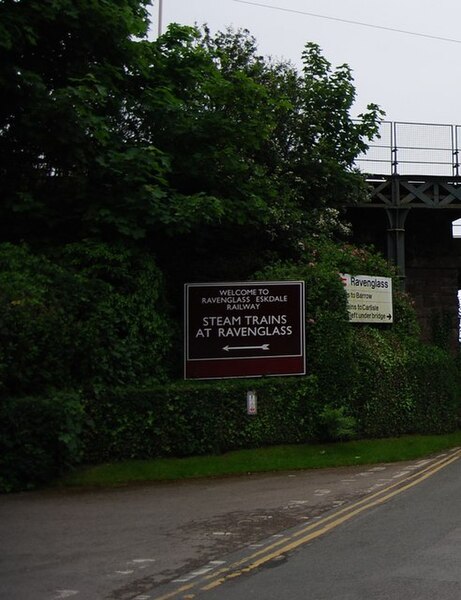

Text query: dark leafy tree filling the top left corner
(0, 0), (182, 244)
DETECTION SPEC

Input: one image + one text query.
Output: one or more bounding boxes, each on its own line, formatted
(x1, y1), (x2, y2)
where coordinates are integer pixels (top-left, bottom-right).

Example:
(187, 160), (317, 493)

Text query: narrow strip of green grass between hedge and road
(56, 431), (461, 487)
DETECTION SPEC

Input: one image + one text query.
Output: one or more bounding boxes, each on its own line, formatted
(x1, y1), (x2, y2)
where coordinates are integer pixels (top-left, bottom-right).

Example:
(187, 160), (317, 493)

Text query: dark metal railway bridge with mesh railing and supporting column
(348, 121), (461, 345)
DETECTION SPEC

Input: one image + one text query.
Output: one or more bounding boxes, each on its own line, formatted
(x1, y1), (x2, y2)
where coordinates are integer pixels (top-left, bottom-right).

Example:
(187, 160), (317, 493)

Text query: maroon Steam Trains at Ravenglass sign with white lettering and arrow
(184, 281), (306, 379)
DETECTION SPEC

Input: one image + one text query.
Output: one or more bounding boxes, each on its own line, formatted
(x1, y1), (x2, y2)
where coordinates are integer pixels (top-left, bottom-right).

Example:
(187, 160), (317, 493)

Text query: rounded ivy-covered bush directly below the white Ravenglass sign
(351, 327), (461, 437)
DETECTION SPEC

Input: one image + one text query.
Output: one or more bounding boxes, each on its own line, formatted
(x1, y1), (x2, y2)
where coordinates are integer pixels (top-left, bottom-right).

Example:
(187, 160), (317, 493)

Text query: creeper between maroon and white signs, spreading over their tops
(257, 240), (402, 408)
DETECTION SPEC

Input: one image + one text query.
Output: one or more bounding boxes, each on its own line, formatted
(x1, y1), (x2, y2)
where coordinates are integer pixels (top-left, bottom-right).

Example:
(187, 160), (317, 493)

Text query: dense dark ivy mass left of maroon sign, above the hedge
(0, 243), (172, 396)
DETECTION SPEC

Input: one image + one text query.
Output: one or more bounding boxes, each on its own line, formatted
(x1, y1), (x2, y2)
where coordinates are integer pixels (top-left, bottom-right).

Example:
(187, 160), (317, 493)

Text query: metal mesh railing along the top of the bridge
(356, 121), (461, 177)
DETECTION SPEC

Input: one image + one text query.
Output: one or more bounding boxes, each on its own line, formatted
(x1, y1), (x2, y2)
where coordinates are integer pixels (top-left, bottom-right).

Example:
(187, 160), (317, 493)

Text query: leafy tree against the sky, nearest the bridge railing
(199, 31), (382, 231)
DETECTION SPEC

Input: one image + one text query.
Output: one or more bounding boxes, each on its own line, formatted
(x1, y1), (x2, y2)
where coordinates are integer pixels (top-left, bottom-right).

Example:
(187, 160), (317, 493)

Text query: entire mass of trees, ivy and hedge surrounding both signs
(0, 5), (459, 489)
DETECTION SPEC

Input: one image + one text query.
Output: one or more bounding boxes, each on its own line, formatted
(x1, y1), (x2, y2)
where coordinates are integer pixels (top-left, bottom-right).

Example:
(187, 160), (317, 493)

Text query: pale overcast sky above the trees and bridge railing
(152, 0), (461, 124)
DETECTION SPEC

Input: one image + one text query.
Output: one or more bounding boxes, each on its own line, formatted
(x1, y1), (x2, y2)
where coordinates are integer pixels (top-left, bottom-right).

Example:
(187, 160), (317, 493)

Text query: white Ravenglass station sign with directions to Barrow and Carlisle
(340, 273), (394, 323)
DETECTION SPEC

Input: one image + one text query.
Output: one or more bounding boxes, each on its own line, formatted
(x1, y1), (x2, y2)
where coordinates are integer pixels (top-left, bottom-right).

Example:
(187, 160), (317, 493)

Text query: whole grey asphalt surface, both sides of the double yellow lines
(0, 453), (461, 600)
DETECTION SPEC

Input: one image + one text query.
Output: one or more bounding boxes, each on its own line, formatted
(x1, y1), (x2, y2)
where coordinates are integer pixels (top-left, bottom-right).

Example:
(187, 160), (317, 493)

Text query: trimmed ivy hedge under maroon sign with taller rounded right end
(80, 327), (460, 463)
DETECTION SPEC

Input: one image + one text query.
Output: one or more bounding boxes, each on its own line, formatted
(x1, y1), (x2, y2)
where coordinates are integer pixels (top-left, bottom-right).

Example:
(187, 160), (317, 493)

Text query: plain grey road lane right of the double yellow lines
(199, 450), (461, 600)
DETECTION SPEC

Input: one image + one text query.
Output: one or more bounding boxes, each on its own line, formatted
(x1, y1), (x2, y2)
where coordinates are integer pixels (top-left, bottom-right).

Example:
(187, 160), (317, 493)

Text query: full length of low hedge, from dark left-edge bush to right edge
(0, 338), (460, 491)
